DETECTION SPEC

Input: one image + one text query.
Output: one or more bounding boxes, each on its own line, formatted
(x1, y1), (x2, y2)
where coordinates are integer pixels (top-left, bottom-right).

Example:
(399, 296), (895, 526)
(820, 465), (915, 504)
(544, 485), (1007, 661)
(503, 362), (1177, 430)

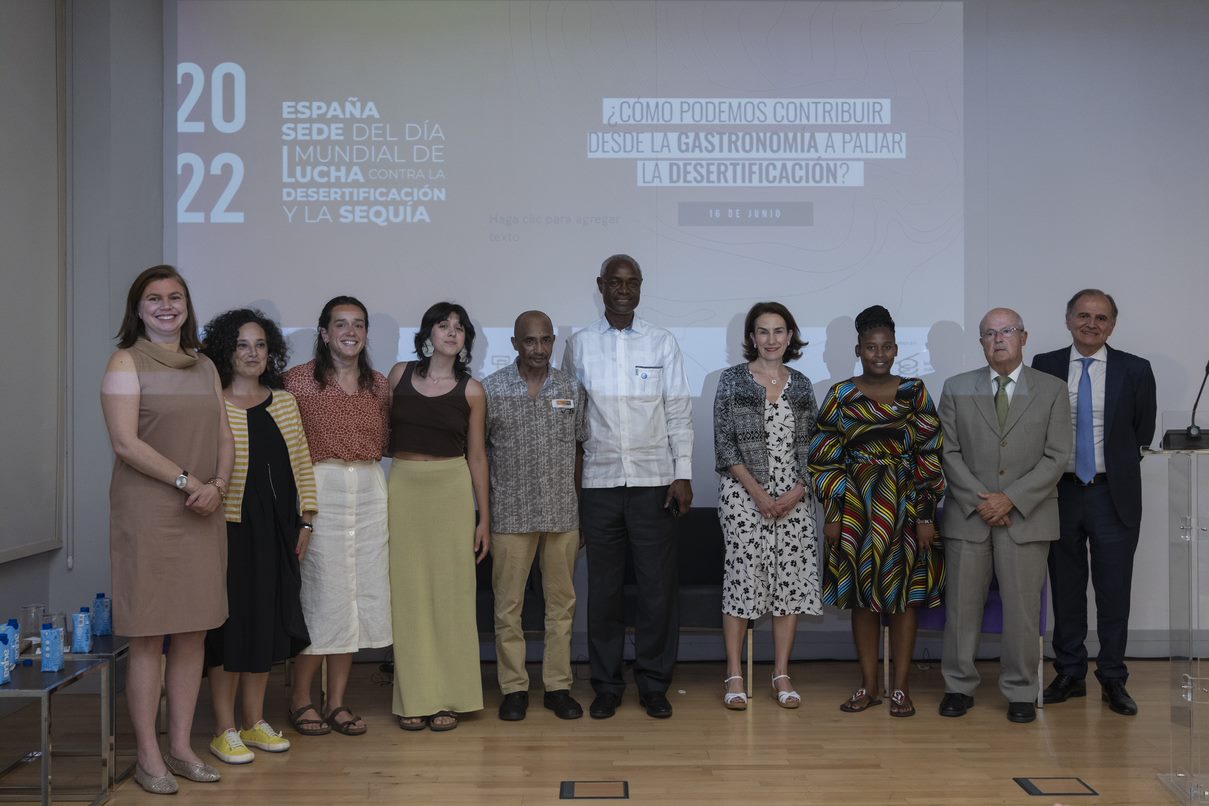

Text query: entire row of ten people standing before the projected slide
(102, 255), (1155, 793)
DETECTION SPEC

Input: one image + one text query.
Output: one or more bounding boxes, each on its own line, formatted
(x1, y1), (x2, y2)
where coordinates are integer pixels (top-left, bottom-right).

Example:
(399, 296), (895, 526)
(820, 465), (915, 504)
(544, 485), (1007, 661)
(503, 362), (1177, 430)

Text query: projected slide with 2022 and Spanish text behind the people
(164, 0), (973, 410)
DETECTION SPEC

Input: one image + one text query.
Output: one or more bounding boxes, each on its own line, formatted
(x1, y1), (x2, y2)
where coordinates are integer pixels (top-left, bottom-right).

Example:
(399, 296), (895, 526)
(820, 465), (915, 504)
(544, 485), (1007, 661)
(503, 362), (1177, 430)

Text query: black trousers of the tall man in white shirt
(579, 487), (679, 696)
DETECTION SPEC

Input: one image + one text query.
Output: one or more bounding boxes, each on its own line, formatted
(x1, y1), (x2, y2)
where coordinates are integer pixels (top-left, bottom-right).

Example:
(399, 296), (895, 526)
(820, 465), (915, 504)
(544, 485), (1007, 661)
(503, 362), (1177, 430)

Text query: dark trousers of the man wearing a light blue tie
(1049, 476), (1138, 682)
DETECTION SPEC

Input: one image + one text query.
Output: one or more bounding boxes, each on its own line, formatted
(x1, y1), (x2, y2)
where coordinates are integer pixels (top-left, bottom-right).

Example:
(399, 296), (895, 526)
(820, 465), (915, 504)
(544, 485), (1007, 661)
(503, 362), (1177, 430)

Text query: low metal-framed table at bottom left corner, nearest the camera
(0, 659), (111, 806)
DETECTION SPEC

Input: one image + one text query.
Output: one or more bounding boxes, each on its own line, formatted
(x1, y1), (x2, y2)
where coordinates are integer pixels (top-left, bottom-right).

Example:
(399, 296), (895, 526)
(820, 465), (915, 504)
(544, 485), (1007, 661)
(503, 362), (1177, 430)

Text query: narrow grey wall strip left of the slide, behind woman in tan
(50, 0), (163, 609)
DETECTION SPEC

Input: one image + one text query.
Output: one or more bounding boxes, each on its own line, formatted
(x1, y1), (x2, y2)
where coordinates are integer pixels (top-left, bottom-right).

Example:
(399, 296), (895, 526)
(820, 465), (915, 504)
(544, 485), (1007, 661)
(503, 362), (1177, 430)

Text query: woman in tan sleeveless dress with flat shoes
(100, 266), (235, 794)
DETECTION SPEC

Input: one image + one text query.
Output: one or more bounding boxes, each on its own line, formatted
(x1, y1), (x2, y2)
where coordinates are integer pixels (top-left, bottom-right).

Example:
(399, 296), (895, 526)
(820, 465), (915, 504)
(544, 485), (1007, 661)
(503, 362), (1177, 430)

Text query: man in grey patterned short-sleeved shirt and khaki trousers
(482, 311), (586, 721)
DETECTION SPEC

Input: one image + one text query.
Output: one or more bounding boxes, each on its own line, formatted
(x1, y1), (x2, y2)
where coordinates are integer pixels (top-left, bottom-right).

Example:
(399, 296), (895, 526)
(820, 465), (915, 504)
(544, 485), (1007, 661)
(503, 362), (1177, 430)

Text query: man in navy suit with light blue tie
(1032, 289), (1157, 717)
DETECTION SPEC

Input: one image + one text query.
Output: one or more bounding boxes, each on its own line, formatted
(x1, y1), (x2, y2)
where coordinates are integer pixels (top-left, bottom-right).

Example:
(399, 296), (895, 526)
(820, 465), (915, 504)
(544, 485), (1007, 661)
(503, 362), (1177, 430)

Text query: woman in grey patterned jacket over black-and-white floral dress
(713, 302), (822, 711)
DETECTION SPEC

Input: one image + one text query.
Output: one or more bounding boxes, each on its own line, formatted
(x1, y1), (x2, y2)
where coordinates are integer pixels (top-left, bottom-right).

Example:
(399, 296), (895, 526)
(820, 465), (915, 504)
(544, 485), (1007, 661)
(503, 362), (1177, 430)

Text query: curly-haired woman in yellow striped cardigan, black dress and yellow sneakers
(203, 308), (326, 764)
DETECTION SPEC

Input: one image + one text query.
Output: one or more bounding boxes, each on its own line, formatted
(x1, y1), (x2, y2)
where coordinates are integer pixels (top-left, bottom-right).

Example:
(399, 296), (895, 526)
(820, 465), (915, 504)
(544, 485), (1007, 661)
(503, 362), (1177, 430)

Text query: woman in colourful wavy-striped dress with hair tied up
(810, 306), (944, 717)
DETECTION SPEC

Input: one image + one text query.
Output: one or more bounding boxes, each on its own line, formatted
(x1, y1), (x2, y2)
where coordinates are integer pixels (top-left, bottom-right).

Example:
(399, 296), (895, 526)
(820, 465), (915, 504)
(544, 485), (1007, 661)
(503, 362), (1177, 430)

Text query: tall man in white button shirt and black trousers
(562, 255), (693, 719)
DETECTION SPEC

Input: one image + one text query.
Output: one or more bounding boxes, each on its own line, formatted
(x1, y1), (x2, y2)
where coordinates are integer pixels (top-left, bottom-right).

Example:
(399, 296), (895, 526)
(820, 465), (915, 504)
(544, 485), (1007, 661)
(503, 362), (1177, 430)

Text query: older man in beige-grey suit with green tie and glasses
(941, 308), (1075, 723)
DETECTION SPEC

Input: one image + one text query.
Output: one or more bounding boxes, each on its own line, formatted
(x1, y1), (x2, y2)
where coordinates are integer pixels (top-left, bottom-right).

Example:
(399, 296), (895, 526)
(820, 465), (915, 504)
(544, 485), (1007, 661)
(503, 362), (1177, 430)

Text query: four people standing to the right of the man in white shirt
(715, 289), (1157, 723)
